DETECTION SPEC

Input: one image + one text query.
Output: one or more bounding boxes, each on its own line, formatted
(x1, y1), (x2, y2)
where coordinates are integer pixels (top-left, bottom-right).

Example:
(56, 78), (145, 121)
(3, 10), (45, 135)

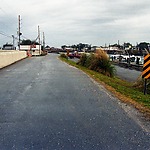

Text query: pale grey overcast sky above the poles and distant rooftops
(0, 0), (150, 47)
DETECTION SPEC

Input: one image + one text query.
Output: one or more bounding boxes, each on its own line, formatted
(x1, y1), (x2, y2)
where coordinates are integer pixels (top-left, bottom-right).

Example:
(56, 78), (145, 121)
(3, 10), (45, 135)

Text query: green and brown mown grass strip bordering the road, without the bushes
(60, 57), (150, 117)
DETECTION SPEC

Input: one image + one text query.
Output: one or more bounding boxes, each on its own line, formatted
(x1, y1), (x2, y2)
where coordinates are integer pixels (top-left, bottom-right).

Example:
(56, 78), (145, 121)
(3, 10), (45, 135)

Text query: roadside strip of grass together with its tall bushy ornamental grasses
(60, 51), (150, 118)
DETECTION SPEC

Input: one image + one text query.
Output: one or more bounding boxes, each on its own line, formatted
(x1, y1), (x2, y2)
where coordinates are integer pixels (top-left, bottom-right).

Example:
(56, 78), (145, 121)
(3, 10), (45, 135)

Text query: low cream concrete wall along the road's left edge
(0, 50), (27, 68)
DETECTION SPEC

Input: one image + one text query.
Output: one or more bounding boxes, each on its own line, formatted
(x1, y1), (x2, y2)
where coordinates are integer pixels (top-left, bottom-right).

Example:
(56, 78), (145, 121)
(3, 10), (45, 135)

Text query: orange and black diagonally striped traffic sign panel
(142, 54), (150, 79)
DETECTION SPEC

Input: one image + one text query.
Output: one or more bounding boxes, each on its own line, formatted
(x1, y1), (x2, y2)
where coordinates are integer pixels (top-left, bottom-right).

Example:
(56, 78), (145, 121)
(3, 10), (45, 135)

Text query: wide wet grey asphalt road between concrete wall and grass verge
(0, 54), (150, 150)
